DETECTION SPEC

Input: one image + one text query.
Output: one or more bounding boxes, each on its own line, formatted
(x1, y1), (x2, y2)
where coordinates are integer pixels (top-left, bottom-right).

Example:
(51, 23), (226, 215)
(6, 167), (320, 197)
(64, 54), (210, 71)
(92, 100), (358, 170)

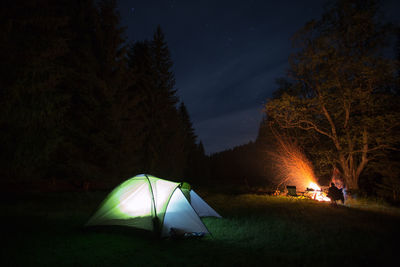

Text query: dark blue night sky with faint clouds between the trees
(118, 0), (399, 154)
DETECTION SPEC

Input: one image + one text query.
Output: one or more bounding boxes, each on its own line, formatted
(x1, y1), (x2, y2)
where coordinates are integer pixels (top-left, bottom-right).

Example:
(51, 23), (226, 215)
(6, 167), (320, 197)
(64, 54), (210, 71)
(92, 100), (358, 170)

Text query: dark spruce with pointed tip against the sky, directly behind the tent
(128, 27), (185, 179)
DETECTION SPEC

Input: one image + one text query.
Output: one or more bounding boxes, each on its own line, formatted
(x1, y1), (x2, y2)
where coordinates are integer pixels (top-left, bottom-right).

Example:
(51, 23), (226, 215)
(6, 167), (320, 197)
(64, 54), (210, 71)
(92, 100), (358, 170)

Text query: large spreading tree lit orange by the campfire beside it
(265, 0), (400, 193)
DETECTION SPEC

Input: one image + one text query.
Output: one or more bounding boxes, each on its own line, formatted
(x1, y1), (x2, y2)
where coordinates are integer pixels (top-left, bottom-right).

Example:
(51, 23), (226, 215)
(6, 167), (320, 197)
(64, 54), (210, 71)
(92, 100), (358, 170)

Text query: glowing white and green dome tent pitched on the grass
(86, 174), (221, 236)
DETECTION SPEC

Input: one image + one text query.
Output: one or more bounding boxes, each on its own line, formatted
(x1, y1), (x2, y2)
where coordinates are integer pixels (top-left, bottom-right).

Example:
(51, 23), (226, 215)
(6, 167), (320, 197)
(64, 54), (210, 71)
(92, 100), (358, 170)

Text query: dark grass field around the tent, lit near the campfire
(0, 192), (400, 266)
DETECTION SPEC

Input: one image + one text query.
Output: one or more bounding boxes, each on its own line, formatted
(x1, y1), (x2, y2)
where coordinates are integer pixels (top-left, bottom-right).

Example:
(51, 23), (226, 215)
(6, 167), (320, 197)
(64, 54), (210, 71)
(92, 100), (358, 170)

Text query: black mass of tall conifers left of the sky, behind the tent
(0, 0), (204, 191)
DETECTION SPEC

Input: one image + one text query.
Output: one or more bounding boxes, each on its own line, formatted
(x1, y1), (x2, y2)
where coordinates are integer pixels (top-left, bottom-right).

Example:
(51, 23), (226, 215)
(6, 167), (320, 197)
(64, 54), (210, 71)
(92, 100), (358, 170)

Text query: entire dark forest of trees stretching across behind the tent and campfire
(0, 0), (400, 201)
